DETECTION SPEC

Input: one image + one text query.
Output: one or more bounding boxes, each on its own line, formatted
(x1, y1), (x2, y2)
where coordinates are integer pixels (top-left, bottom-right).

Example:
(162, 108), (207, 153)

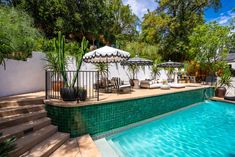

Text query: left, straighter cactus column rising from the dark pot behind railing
(54, 31), (68, 86)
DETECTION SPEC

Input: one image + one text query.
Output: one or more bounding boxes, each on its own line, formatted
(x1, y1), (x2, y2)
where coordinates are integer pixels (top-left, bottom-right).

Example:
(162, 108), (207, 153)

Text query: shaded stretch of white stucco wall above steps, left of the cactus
(0, 52), (45, 97)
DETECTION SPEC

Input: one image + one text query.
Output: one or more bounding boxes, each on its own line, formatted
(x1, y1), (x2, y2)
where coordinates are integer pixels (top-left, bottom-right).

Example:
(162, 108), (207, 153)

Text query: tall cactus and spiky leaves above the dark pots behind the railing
(42, 32), (88, 87)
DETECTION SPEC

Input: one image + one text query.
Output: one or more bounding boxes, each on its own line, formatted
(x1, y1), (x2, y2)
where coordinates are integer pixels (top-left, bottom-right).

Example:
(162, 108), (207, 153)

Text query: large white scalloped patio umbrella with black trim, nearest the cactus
(83, 46), (130, 79)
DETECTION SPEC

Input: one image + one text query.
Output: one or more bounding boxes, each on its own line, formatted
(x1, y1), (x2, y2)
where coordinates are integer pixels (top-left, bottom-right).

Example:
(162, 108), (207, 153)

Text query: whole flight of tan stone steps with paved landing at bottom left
(0, 92), (101, 157)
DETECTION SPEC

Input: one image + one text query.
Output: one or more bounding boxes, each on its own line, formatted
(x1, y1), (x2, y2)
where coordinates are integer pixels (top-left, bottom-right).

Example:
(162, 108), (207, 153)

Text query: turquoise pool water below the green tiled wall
(106, 101), (235, 157)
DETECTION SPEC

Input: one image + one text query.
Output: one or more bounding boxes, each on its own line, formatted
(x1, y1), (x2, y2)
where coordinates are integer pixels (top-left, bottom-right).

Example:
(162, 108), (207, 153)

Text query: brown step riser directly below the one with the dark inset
(9, 125), (57, 157)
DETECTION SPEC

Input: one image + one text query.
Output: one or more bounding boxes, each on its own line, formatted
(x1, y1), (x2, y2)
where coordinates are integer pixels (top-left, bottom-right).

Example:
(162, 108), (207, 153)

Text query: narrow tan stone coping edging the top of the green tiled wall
(44, 86), (213, 108)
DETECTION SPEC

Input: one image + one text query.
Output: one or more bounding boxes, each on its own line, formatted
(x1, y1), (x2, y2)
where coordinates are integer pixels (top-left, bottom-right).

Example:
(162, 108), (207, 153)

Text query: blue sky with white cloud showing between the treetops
(123, 0), (235, 25)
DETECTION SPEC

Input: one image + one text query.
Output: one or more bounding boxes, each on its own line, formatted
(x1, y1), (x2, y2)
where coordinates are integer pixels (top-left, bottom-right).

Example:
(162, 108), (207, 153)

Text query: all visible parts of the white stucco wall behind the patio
(0, 52), (170, 97)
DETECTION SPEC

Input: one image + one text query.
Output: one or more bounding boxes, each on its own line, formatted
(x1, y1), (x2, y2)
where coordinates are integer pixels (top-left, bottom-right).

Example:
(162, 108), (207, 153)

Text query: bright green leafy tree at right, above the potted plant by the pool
(189, 22), (230, 75)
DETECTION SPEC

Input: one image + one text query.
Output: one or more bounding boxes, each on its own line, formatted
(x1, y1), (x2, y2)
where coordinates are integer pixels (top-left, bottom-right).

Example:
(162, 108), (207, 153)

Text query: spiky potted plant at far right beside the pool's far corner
(215, 67), (232, 98)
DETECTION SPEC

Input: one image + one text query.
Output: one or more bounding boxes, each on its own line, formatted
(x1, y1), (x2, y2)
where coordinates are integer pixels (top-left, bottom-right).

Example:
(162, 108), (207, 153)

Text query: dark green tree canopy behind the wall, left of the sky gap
(3, 0), (138, 45)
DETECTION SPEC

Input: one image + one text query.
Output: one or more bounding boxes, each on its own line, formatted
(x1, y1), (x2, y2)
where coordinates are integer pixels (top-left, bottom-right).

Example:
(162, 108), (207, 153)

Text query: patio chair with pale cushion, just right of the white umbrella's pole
(111, 77), (131, 93)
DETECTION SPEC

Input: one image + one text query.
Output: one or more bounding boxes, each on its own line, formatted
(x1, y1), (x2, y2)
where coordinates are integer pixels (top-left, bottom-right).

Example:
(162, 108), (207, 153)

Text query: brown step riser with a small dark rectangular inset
(0, 117), (51, 142)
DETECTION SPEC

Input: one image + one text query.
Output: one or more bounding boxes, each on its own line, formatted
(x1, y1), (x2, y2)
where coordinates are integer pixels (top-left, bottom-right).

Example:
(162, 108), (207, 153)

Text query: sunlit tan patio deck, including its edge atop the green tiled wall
(44, 83), (209, 107)
